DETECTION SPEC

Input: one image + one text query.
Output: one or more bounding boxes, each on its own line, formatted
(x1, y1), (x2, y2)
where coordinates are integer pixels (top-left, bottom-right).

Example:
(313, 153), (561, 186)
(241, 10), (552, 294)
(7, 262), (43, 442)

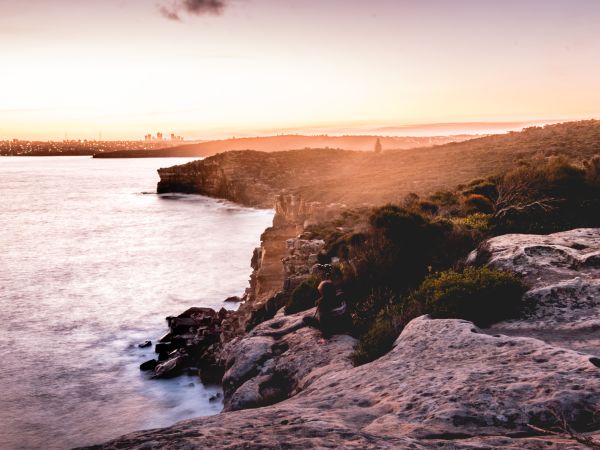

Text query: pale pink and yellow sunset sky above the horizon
(0, 0), (600, 139)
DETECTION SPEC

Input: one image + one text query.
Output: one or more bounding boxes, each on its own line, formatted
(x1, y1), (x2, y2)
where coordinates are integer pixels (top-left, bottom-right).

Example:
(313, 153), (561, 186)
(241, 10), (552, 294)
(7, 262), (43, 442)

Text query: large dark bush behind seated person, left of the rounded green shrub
(341, 205), (482, 326)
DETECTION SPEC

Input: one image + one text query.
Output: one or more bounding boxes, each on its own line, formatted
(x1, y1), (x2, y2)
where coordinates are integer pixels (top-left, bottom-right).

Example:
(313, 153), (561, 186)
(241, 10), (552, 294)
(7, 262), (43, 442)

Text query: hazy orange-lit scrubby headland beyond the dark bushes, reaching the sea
(161, 120), (600, 204)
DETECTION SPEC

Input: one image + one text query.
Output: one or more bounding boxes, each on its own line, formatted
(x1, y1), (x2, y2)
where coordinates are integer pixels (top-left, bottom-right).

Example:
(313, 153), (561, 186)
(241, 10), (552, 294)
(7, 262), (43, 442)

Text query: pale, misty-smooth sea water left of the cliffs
(0, 157), (272, 449)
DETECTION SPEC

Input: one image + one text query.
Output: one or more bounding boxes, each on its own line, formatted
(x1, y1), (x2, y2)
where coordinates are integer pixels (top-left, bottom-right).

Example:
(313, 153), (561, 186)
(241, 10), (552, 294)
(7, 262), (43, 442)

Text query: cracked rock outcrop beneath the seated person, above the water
(223, 308), (356, 411)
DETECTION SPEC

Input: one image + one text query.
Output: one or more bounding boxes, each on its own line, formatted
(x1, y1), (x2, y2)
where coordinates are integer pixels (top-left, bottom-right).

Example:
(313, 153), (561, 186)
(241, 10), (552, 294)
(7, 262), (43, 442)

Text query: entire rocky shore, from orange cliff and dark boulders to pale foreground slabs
(88, 153), (600, 449)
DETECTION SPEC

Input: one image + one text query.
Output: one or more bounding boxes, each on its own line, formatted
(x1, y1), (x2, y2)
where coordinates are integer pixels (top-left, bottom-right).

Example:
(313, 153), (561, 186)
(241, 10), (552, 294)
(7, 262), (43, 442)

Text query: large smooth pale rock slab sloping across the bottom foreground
(91, 317), (600, 449)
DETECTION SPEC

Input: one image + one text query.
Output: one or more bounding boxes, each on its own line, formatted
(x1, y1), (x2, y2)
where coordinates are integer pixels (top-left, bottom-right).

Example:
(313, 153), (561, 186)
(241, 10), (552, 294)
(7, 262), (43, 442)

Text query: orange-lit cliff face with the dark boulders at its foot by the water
(140, 195), (344, 394)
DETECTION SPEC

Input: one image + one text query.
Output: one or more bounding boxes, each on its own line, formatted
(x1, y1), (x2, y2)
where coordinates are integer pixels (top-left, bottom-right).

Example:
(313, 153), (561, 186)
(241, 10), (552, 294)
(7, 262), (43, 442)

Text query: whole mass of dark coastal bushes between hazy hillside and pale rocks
(308, 152), (600, 364)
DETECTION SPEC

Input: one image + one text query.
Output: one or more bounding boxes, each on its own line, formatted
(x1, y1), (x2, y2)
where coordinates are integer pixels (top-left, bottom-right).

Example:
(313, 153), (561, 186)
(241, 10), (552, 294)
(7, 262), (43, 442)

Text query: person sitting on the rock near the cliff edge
(304, 280), (350, 343)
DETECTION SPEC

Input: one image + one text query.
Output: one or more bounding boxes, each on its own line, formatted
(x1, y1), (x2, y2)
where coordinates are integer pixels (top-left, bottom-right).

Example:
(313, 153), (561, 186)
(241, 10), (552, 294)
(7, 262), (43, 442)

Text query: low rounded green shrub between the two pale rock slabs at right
(414, 267), (527, 327)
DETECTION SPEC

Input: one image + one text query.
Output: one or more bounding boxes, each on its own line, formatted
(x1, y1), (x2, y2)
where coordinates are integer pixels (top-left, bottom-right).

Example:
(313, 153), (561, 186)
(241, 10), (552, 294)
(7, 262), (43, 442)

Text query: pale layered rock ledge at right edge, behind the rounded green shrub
(470, 228), (600, 355)
